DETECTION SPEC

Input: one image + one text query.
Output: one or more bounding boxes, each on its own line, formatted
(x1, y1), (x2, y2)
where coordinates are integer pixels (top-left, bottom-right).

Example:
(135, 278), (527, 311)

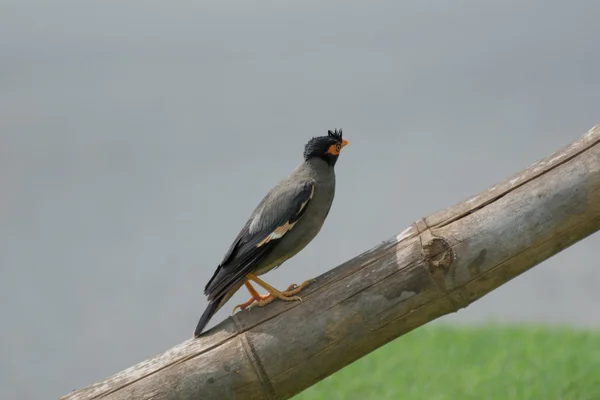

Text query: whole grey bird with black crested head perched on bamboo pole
(194, 129), (348, 337)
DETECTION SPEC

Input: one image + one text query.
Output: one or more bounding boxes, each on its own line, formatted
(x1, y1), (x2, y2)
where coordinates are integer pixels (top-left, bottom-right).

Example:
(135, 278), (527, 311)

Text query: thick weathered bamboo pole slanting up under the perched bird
(61, 125), (600, 400)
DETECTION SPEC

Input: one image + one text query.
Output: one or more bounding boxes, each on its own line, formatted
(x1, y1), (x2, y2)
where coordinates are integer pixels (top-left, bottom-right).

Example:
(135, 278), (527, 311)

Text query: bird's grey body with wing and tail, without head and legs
(194, 158), (335, 336)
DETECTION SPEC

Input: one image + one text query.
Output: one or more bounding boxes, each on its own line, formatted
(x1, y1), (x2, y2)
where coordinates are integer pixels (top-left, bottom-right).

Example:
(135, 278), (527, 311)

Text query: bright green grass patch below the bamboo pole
(294, 324), (600, 400)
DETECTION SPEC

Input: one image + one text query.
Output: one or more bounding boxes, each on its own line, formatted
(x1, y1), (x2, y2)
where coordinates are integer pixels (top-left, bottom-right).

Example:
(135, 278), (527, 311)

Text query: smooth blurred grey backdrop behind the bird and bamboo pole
(0, 0), (600, 399)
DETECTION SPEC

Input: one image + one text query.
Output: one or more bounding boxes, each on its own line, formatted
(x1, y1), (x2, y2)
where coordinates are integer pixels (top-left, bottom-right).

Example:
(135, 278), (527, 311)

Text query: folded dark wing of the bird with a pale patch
(204, 181), (315, 301)
